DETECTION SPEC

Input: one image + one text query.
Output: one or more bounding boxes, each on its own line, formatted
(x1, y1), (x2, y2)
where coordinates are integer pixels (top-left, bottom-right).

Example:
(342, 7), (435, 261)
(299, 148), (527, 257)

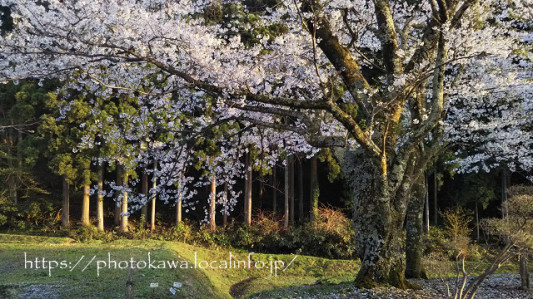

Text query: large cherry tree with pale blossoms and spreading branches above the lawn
(0, 0), (532, 288)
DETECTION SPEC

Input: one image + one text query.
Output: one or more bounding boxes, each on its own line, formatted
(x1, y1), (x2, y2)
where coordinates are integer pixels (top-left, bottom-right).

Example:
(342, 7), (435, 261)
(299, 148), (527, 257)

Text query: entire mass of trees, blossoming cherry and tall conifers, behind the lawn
(0, 0), (533, 298)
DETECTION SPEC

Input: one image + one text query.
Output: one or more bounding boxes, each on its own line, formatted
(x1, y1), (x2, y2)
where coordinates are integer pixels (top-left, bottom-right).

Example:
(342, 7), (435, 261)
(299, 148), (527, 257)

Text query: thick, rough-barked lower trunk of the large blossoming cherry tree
(343, 152), (410, 289)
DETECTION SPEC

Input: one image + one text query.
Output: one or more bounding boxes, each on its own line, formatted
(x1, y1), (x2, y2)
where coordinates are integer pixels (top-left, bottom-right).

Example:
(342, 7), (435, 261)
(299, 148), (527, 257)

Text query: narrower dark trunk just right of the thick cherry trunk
(405, 178), (427, 279)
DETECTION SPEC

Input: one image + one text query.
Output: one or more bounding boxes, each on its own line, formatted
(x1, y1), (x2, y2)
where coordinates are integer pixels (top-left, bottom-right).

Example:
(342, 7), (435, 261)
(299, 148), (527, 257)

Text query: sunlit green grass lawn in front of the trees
(0, 234), (358, 298)
